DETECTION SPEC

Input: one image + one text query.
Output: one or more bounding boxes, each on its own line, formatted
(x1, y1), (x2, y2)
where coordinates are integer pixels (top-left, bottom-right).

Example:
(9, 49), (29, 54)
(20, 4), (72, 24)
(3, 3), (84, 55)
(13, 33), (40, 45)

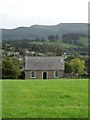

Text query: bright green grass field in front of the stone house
(2, 79), (88, 118)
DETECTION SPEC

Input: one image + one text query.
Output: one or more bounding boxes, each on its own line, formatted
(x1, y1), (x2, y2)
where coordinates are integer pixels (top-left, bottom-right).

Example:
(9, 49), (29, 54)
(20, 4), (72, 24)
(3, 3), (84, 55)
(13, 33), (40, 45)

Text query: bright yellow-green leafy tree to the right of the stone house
(70, 58), (85, 76)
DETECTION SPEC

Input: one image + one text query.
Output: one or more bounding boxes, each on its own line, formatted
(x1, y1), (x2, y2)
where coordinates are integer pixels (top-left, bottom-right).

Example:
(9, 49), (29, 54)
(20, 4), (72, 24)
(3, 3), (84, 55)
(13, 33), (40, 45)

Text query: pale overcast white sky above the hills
(0, 0), (89, 29)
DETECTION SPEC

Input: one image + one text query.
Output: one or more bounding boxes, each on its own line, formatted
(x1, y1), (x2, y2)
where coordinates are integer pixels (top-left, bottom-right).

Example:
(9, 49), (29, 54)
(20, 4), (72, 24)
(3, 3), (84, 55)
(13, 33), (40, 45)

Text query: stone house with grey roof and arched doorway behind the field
(25, 56), (64, 79)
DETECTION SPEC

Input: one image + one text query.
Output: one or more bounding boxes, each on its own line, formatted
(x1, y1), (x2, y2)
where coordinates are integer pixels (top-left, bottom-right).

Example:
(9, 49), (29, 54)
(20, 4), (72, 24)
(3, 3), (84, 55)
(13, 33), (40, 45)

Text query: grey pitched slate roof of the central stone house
(25, 56), (64, 70)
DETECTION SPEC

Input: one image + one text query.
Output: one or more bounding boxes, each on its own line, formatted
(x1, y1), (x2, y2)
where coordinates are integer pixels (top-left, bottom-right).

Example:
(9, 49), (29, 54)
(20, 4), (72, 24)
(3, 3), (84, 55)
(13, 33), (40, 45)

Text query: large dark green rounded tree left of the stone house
(2, 57), (20, 79)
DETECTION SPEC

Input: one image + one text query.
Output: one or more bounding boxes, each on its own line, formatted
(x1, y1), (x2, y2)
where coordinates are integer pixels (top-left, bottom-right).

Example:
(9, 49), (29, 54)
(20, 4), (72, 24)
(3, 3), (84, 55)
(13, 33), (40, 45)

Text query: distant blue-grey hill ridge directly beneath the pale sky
(2, 23), (88, 40)
